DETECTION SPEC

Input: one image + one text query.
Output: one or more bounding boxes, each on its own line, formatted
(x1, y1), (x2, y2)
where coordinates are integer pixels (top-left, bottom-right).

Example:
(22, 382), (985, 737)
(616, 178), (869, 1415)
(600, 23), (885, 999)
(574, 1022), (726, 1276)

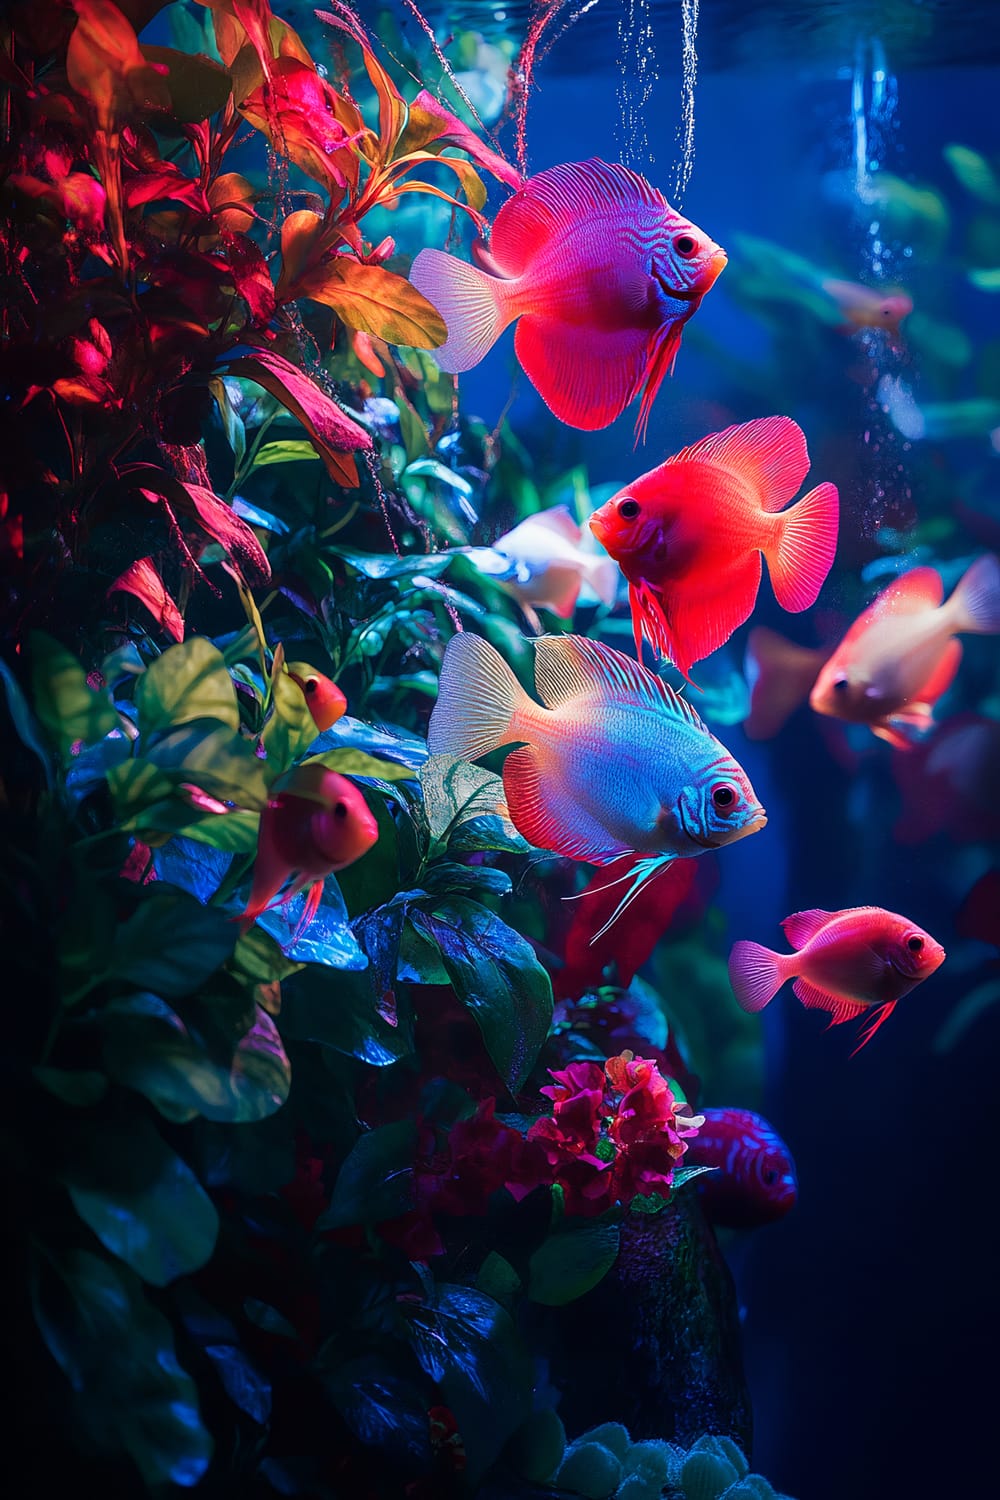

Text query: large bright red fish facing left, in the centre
(591, 417), (838, 677)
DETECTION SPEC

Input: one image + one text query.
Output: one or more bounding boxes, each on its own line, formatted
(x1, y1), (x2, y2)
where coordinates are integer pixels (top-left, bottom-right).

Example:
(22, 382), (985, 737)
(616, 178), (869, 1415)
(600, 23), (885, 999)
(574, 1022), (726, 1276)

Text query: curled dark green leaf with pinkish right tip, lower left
(105, 995), (291, 1125)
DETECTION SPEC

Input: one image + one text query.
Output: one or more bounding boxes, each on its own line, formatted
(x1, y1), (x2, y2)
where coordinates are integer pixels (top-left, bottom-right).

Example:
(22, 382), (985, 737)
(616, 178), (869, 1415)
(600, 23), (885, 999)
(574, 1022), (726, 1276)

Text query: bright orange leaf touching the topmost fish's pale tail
(298, 255), (448, 350)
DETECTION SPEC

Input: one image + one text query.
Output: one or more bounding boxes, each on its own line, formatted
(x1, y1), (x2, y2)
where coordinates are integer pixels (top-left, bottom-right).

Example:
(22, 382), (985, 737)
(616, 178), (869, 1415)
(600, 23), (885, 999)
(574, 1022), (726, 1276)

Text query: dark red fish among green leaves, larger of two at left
(240, 764), (378, 938)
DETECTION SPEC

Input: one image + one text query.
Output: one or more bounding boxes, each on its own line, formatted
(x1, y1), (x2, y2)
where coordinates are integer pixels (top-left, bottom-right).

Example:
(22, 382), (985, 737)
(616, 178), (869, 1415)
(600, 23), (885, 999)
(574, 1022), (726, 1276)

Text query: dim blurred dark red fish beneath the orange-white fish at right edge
(892, 714), (1000, 845)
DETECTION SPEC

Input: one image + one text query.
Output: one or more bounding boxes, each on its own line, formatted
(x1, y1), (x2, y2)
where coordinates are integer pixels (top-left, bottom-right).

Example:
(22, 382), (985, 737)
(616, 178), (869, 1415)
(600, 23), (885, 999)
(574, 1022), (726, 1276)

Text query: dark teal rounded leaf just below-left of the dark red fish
(108, 881), (237, 998)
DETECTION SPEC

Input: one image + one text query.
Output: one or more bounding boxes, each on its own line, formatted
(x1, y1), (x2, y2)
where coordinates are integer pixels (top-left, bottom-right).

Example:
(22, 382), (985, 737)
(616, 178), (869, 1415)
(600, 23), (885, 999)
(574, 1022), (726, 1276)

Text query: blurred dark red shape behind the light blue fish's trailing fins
(552, 857), (705, 999)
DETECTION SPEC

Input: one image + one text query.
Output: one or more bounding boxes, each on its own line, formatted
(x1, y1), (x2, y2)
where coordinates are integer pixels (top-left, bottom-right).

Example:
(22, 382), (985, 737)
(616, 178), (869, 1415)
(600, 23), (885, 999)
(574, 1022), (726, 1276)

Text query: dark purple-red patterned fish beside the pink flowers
(685, 1109), (798, 1229)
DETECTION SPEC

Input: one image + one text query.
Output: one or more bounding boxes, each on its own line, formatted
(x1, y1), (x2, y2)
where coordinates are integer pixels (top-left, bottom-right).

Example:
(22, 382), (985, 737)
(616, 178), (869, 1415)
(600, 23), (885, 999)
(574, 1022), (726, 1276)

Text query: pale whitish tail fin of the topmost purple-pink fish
(409, 249), (514, 375)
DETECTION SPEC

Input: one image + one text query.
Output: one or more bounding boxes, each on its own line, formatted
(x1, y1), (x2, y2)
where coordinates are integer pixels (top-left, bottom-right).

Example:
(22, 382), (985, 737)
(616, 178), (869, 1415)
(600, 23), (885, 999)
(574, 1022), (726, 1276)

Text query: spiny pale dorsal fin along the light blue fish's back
(535, 636), (709, 734)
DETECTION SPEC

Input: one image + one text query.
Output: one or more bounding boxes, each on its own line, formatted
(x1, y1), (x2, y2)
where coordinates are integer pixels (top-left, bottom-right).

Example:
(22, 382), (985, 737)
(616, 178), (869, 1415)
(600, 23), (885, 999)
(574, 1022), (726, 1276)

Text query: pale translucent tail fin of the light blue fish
(427, 630), (531, 761)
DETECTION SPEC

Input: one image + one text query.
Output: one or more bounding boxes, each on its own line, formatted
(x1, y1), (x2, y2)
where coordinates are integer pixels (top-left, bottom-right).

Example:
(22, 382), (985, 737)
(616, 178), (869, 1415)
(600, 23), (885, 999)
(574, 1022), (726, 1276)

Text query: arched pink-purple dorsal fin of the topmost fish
(489, 156), (670, 278)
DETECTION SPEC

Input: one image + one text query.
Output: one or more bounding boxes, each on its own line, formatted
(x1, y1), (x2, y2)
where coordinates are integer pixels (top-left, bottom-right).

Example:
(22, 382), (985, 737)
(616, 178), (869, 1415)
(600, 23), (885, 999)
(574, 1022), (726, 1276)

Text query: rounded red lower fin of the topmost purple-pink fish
(514, 312), (649, 432)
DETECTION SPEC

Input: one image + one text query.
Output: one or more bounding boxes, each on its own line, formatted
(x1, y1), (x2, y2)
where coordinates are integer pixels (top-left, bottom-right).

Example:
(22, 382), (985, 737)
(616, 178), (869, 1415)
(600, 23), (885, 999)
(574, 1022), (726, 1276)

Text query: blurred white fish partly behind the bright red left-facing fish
(469, 506), (618, 620)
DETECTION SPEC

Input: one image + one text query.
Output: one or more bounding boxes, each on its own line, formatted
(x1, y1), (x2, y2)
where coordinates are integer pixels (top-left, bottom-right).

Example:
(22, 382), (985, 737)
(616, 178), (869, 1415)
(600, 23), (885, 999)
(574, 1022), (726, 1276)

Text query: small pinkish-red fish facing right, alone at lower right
(729, 906), (945, 1056)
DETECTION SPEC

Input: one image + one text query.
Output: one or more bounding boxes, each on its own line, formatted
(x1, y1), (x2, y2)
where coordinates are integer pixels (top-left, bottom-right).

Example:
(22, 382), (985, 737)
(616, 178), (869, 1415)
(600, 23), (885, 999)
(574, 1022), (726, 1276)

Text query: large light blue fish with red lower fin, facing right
(427, 630), (768, 939)
